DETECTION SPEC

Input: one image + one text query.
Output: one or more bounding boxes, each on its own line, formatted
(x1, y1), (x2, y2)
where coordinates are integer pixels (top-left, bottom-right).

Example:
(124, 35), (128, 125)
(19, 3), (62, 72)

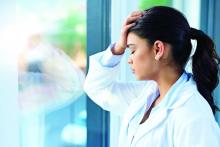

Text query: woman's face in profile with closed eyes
(127, 32), (159, 80)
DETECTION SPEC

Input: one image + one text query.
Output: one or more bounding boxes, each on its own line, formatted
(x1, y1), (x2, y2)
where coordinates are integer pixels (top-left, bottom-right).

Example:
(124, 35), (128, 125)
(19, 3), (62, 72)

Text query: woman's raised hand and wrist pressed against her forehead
(112, 11), (143, 55)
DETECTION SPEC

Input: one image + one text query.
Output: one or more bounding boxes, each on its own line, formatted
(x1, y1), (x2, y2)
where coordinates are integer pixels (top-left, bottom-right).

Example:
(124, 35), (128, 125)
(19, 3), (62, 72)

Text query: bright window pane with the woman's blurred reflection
(16, 0), (87, 147)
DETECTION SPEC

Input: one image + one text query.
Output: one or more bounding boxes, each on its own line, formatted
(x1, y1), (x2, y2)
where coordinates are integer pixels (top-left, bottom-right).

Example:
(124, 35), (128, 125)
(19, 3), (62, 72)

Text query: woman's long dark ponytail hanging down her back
(190, 28), (220, 113)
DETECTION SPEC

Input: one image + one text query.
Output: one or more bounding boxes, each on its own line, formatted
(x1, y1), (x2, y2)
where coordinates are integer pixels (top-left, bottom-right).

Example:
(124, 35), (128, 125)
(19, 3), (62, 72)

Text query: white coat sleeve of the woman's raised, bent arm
(84, 44), (148, 115)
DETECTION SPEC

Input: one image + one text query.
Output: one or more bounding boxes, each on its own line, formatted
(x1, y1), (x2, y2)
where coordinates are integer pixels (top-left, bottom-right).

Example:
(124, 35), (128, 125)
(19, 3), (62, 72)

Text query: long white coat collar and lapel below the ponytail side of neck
(133, 72), (196, 144)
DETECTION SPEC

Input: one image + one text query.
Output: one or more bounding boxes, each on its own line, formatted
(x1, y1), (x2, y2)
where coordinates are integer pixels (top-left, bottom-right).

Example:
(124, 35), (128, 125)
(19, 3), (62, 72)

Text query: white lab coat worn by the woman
(84, 47), (220, 147)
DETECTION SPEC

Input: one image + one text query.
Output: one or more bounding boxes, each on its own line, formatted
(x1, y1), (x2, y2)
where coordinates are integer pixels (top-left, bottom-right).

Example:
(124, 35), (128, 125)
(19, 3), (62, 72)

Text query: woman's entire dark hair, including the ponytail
(129, 6), (220, 113)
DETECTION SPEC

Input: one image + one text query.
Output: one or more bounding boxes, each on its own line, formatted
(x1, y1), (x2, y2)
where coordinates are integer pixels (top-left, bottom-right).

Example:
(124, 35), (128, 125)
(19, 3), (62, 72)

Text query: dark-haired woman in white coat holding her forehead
(85, 6), (220, 147)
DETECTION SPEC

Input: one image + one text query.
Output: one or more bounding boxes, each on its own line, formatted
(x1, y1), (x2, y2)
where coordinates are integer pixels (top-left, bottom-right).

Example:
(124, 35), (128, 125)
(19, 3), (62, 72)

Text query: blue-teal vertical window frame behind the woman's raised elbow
(86, 0), (111, 147)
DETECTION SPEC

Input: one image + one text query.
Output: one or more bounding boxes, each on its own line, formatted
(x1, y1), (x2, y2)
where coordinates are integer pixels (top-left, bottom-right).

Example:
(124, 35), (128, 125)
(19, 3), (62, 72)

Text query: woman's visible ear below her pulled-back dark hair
(154, 40), (165, 61)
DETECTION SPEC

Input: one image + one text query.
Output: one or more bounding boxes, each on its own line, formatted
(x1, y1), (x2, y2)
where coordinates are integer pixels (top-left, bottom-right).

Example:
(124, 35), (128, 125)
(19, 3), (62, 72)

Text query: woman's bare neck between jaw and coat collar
(154, 68), (182, 106)
